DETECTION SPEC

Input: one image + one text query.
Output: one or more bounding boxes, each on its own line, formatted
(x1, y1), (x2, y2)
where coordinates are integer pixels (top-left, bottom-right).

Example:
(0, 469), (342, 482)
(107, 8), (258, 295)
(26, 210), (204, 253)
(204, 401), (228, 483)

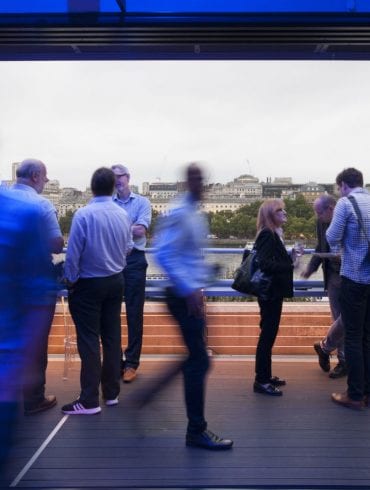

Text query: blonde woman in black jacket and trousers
(253, 199), (293, 396)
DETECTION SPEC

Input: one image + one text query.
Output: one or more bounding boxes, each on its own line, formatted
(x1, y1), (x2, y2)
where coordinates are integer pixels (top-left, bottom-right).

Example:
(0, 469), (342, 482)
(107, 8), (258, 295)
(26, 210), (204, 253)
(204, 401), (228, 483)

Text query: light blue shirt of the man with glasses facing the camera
(113, 192), (152, 250)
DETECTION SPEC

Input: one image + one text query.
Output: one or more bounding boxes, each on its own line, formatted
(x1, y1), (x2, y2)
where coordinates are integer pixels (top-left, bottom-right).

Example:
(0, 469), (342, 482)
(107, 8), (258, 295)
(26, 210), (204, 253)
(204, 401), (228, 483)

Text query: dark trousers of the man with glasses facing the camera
(123, 248), (148, 369)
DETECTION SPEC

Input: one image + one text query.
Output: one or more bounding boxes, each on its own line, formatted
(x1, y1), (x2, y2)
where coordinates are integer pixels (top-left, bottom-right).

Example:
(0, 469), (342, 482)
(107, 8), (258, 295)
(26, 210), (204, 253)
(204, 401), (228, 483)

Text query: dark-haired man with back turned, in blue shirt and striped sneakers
(62, 168), (131, 415)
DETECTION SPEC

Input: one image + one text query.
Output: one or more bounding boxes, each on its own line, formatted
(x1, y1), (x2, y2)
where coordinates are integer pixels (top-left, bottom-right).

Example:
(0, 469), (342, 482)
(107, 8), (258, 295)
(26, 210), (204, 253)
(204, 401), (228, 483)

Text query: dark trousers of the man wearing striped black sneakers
(68, 273), (124, 408)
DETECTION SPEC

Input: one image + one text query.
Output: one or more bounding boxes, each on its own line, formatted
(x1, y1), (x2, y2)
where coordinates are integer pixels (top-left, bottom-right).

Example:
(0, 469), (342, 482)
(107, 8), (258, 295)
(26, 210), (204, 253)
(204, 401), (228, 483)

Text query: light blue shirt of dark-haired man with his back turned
(65, 196), (131, 283)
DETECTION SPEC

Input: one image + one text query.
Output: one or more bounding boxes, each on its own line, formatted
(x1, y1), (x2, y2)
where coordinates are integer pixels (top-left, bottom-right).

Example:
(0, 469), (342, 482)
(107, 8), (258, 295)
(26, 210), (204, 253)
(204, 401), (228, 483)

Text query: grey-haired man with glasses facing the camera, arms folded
(112, 164), (152, 383)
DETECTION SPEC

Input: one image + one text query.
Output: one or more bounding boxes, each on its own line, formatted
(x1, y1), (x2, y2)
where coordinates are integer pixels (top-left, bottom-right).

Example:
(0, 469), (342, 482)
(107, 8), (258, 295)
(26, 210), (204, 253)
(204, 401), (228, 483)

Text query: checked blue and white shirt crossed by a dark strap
(326, 187), (370, 284)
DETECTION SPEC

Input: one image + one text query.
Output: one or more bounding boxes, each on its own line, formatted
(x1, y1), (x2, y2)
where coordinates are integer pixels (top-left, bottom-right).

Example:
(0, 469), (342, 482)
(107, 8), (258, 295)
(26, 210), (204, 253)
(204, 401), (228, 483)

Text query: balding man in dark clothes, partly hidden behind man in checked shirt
(301, 194), (347, 379)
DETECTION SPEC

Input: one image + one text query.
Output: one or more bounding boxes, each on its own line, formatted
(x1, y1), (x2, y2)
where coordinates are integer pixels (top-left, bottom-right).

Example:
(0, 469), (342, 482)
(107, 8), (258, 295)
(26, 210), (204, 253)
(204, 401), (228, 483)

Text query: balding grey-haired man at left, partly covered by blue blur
(11, 158), (64, 415)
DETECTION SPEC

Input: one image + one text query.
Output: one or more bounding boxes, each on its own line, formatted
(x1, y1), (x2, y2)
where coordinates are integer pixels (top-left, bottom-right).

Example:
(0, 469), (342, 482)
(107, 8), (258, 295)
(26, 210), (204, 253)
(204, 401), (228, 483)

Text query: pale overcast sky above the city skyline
(0, 61), (370, 189)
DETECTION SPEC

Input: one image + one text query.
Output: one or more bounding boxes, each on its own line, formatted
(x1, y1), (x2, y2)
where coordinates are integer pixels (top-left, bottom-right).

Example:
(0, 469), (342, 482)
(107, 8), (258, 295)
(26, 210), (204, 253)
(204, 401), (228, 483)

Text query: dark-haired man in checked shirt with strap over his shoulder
(326, 168), (370, 410)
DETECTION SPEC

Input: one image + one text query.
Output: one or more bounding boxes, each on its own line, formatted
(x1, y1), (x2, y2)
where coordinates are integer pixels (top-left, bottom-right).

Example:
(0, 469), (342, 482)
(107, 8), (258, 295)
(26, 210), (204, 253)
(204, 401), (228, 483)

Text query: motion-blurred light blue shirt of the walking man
(154, 194), (212, 297)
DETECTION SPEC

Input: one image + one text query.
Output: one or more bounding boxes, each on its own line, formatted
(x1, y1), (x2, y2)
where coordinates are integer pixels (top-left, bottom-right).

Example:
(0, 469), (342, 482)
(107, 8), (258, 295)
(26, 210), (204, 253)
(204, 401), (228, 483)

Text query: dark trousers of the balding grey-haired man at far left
(23, 298), (56, 410)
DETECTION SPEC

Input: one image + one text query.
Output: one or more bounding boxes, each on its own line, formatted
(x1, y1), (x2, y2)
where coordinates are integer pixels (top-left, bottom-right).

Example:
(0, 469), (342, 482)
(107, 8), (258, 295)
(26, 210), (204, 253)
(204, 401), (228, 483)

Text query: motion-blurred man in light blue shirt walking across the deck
(155, 163), (233, 449)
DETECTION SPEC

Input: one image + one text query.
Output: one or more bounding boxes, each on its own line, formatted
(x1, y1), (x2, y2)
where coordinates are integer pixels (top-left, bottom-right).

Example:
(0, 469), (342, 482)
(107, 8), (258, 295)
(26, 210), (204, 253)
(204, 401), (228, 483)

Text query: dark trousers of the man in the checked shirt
(340, 277), (370, 400)
